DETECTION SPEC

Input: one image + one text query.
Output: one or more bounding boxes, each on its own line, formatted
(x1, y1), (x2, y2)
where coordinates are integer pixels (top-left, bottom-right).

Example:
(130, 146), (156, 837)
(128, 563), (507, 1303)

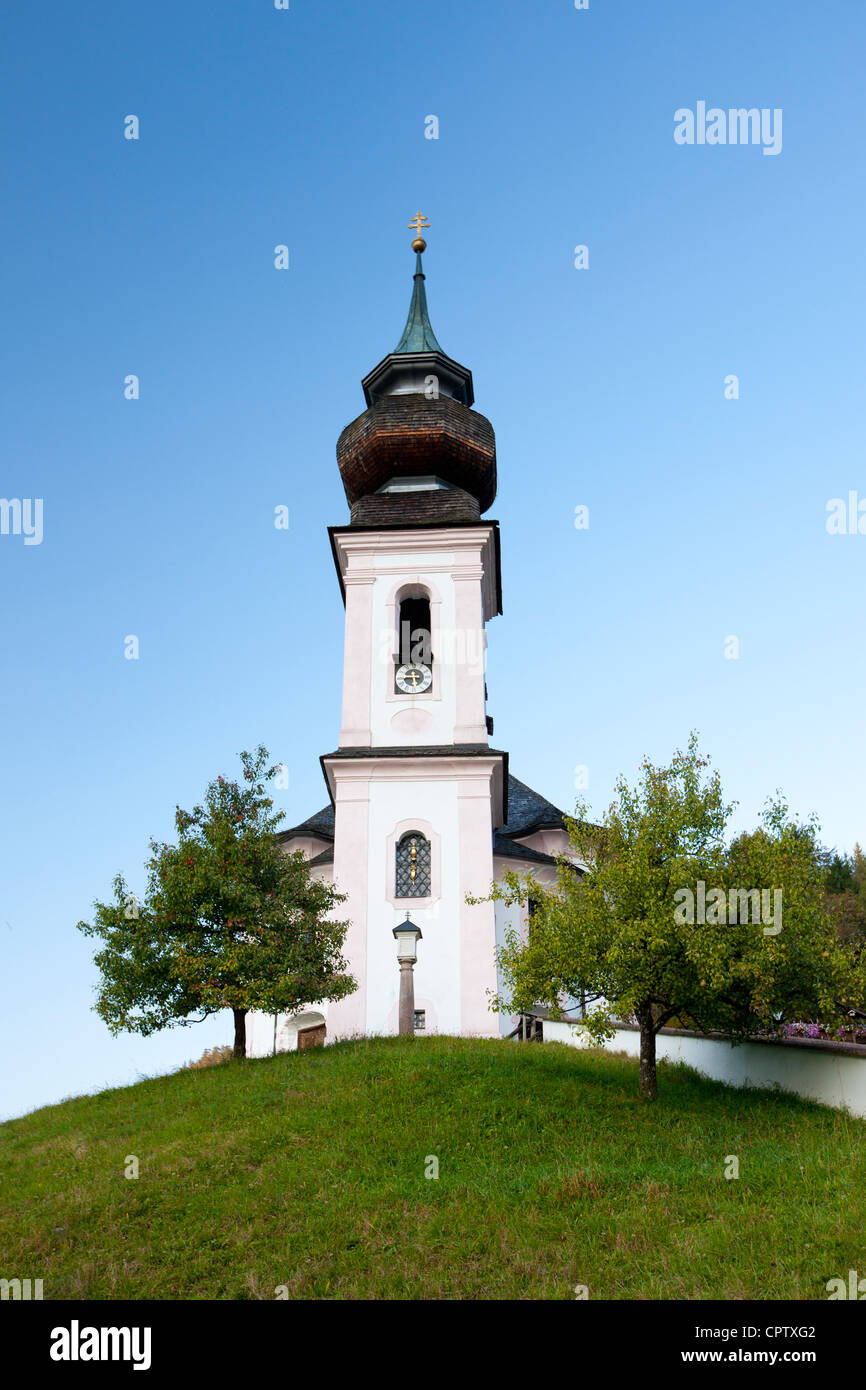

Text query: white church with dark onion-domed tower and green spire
(247, 222), (567, 1055)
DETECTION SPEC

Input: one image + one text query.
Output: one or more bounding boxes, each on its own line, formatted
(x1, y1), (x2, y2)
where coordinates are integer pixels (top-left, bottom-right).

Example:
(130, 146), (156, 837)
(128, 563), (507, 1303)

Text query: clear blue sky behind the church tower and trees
(0, 0), (866, 1115)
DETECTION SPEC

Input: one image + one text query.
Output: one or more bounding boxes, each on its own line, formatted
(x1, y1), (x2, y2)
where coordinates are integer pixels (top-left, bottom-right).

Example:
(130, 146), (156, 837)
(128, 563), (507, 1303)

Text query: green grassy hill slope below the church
(0, 1037), (866, 1300)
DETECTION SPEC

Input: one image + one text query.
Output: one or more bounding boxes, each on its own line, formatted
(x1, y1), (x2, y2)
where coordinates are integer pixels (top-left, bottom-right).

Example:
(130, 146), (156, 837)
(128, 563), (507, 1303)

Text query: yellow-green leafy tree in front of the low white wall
(491, 734), (865, 1099)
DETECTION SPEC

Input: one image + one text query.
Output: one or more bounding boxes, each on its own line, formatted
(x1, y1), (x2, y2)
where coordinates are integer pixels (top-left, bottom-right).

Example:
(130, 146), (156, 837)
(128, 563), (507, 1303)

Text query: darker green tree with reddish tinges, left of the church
(78, 746), (357, 1058)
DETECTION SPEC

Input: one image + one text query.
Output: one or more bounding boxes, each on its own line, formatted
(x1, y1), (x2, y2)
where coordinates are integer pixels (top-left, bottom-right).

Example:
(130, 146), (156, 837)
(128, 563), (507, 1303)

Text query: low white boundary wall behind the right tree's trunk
(544, 1019), (866, 1118)
